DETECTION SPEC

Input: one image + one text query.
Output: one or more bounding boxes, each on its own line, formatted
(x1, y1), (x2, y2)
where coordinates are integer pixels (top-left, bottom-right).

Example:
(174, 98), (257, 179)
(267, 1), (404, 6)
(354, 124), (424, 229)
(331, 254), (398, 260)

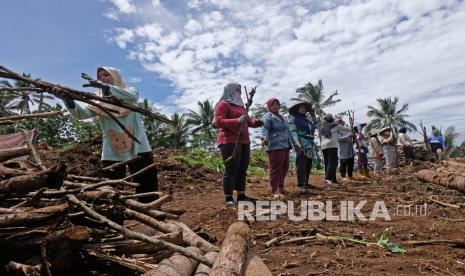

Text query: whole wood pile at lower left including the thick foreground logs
(0, 146), (271, 276)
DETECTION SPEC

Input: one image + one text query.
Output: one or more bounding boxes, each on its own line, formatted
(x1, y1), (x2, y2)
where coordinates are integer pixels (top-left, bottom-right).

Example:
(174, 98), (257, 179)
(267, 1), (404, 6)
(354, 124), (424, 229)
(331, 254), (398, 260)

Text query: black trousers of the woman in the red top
(220, 144), (250, 195)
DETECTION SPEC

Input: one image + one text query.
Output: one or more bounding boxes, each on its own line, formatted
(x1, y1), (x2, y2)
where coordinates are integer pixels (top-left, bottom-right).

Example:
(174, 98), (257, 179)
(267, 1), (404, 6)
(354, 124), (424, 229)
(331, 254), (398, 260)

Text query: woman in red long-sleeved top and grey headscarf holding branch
(215, 83), (263, 207)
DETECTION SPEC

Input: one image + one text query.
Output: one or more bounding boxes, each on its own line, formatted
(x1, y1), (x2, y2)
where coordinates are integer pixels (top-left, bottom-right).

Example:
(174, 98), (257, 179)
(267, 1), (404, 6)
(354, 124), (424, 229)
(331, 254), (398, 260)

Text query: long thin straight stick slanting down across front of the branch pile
(66, 195), (213, 267)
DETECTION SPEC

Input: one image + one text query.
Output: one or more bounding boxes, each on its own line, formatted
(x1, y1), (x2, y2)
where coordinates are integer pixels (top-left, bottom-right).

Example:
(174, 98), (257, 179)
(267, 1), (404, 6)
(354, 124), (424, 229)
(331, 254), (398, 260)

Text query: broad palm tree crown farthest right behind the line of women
(365, 97), (417, 134)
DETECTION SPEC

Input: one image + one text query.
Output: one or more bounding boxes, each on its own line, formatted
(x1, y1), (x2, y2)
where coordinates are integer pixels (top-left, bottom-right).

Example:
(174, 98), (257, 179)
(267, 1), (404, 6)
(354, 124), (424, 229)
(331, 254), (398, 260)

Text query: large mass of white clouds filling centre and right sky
(104, 0), (465, 140)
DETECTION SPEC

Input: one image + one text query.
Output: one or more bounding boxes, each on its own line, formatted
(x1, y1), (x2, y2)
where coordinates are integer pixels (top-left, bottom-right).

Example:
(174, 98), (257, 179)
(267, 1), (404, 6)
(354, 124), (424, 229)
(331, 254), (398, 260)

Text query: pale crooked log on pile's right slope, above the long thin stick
(124, 209), (219, 252)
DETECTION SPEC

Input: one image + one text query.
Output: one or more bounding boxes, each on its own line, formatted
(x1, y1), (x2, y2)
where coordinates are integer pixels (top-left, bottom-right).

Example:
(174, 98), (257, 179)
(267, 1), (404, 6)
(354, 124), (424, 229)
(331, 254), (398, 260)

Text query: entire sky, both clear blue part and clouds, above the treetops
(0, 0), (465, 140)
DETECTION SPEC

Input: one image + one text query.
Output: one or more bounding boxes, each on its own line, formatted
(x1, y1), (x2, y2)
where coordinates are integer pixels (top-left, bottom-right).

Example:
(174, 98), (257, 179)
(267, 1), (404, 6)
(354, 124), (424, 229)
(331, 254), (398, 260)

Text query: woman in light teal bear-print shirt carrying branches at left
(64, 67), (158, 200)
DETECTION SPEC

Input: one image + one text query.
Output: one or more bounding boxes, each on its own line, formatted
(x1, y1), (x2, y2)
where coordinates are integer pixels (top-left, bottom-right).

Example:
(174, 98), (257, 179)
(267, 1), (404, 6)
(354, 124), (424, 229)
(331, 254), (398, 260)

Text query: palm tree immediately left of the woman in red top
(186, 100), (215, 147)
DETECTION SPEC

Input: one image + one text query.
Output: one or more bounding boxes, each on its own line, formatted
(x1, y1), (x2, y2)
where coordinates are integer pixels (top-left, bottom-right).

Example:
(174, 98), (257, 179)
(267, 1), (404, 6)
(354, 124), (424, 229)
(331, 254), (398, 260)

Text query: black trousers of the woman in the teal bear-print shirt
(102, 152), (158, 196)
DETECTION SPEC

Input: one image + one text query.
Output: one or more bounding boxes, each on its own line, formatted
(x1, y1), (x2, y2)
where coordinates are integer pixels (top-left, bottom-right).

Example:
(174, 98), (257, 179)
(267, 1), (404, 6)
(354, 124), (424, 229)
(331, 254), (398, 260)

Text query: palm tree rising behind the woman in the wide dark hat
(292, 80), (341, 140)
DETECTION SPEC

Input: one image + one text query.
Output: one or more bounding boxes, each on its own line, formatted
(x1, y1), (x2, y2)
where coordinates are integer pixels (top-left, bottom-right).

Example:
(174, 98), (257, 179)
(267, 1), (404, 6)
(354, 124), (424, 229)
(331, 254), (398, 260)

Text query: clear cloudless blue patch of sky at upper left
(0, 0), (172, 101)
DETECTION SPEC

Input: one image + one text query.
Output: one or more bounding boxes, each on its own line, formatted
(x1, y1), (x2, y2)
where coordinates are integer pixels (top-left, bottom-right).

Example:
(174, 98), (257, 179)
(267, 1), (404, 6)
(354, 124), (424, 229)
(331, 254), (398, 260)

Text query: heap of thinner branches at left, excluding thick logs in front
(0, 147), (219, 275)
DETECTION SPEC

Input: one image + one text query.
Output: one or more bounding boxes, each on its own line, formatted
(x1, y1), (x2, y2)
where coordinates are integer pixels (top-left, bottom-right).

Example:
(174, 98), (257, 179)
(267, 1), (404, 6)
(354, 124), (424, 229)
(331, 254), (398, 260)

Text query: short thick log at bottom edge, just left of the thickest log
(143, 246), (202, 276)
